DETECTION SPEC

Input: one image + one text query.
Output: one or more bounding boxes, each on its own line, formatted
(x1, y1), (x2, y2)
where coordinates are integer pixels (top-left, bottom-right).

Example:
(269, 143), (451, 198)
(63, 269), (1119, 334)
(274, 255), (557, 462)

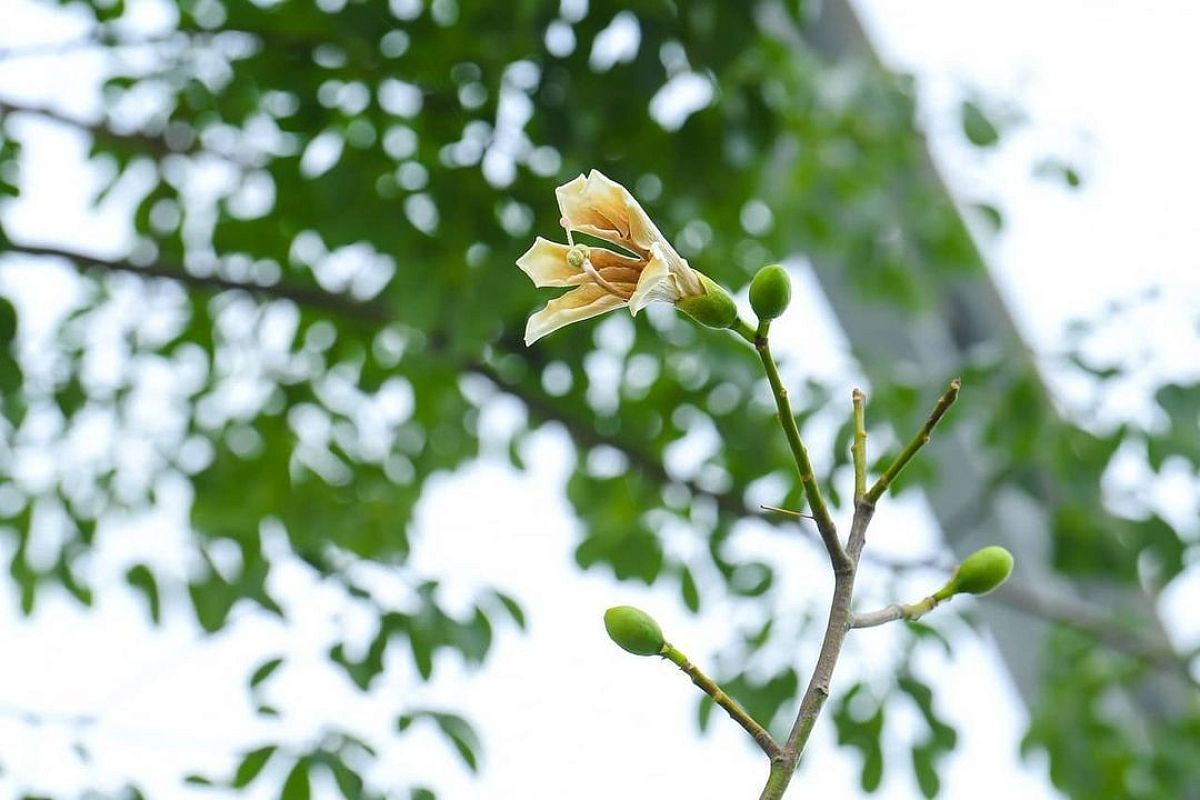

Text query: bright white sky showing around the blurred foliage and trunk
(0, 0), (1200, 800)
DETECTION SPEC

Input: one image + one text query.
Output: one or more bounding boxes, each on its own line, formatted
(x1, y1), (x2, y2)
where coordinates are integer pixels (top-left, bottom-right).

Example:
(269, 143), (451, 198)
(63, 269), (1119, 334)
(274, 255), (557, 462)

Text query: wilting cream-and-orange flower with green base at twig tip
(517, 169), (737, 344)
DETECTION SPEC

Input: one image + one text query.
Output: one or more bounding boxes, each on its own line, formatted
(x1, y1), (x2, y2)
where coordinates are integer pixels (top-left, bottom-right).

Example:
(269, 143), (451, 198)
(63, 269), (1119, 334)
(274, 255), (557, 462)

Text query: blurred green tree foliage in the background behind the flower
(0, 0), (1200, 799)
